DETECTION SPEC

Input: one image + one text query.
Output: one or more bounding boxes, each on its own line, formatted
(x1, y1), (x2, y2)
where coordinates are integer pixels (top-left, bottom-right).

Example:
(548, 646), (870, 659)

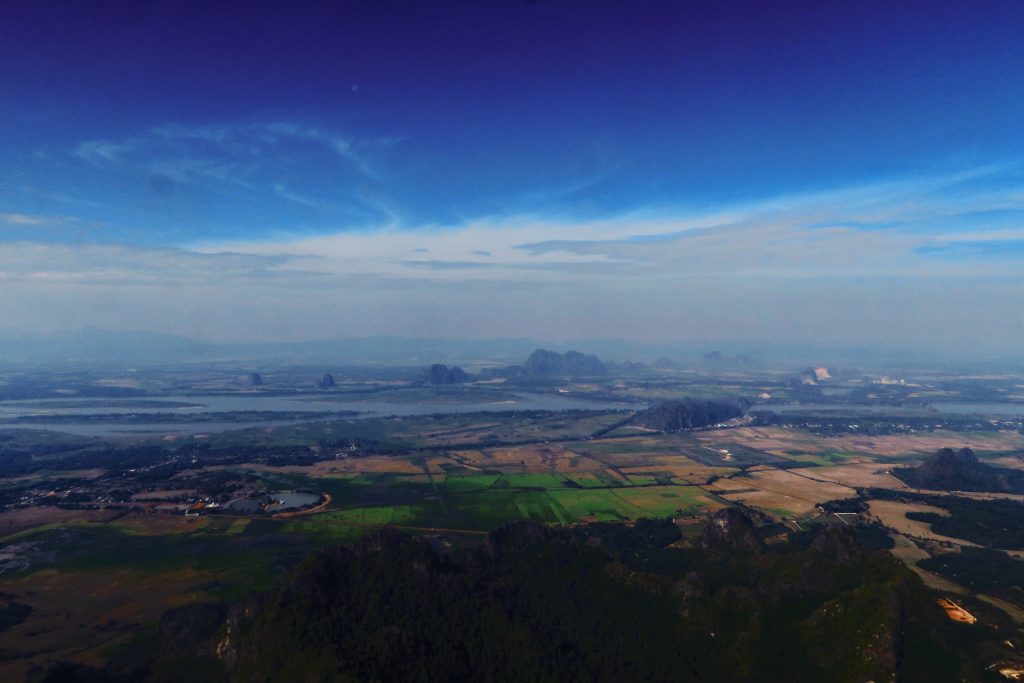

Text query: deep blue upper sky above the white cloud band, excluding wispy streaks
(0, 0), (1024, 243)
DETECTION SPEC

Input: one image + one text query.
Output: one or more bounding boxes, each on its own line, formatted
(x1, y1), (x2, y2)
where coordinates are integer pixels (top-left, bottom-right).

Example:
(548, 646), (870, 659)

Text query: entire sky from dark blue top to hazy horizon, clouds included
(0, 0), (1024, 353)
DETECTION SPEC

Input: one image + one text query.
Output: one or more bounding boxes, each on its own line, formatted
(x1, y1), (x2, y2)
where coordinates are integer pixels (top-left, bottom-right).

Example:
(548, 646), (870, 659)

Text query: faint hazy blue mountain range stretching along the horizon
(0, 328), (1006, 368)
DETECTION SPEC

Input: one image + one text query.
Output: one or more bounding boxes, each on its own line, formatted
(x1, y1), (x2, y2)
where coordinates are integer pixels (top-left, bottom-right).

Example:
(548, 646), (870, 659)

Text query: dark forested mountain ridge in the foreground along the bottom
(37, 510), (976, 682)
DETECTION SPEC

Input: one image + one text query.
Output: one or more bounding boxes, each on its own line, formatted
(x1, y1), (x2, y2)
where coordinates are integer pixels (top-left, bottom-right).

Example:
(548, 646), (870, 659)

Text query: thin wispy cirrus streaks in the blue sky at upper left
(64, 121), (401, 235)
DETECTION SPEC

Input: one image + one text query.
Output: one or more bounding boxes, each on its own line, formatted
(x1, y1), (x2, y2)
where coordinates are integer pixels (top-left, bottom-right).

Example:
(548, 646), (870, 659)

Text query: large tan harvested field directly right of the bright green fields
(705, 469), (856, 517)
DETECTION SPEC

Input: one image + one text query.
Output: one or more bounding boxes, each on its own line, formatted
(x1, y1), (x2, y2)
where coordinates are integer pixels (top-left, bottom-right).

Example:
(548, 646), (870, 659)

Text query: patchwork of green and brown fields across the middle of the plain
(180, 427), (1024, 533)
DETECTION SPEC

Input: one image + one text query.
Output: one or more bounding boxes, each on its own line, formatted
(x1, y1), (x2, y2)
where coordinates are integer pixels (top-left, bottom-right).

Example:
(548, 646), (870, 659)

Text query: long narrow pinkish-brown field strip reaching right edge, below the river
(700, 427), (1024, 457)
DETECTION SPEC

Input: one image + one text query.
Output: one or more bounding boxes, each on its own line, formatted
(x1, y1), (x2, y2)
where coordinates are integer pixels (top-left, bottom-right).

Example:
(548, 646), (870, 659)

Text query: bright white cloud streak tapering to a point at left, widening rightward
(182, 163), (1024, 286)
